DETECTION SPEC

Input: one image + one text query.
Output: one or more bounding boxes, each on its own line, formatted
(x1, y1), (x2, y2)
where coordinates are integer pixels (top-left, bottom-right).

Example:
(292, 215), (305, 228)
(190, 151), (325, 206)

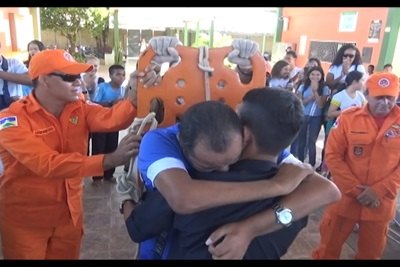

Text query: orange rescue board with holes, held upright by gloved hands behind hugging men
(138, 45), (266, 127)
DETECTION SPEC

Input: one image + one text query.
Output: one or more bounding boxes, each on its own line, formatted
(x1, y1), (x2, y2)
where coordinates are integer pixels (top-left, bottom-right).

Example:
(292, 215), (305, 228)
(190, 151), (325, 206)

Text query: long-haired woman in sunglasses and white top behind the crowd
(326, 44), (366, 93)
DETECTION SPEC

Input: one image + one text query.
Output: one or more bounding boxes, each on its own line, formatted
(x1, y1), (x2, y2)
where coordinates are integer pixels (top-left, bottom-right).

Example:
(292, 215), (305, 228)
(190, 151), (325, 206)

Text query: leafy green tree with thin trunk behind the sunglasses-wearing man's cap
(40, 7), (89, 53)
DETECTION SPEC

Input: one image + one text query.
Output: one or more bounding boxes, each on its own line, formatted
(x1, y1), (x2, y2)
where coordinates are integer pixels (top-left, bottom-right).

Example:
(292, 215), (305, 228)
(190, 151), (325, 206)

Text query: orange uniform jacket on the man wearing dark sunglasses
(0, 94), (136, 227)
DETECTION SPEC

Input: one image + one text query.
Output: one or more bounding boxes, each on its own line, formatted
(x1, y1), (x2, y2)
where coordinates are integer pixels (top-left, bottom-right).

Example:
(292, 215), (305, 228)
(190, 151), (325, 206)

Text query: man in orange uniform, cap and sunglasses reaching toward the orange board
(0, 50), (154, 259)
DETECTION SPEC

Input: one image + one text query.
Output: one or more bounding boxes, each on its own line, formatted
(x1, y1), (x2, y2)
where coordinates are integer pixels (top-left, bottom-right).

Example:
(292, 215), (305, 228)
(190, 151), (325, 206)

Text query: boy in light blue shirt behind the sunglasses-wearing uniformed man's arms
(92, 64), (125, 182)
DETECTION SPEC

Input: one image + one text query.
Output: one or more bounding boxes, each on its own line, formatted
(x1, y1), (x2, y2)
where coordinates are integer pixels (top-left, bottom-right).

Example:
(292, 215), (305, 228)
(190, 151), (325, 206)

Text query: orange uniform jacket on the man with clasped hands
(325, 105), (400, 221)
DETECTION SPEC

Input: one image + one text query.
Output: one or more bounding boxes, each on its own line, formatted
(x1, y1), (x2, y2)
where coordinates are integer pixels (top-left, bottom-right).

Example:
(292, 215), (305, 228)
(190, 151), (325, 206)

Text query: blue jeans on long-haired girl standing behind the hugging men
(297, 115), (322, 166)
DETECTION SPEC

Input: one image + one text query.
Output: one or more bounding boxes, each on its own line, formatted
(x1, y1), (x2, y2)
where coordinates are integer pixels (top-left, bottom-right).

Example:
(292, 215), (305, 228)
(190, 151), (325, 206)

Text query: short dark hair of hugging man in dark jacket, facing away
(239, 87), (304, 156)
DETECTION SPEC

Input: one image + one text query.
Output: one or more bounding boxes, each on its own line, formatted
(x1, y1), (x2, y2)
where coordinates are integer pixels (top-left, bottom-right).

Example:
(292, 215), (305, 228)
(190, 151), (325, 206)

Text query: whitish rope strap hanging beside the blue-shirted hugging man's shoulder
(116, 112), (158, 202)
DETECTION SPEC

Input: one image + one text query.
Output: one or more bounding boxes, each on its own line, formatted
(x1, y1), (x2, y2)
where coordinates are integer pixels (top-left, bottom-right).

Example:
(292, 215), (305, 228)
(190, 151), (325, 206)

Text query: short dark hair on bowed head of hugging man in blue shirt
(179, 101), (243, 155)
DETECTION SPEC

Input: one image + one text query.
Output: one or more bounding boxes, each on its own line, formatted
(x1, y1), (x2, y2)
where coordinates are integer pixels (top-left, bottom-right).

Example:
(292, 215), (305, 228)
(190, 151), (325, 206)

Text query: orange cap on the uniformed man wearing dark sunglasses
(29, 49), (93, 80)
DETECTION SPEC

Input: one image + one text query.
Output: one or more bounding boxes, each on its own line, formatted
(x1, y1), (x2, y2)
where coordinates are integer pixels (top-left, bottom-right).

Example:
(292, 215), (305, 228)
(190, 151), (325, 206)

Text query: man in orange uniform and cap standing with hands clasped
(312, 73), (400, 259)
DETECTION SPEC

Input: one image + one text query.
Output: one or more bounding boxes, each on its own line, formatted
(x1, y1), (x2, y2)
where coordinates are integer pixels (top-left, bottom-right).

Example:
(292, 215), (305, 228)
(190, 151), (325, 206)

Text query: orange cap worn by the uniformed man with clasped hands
(366, 72), (399, 98)
